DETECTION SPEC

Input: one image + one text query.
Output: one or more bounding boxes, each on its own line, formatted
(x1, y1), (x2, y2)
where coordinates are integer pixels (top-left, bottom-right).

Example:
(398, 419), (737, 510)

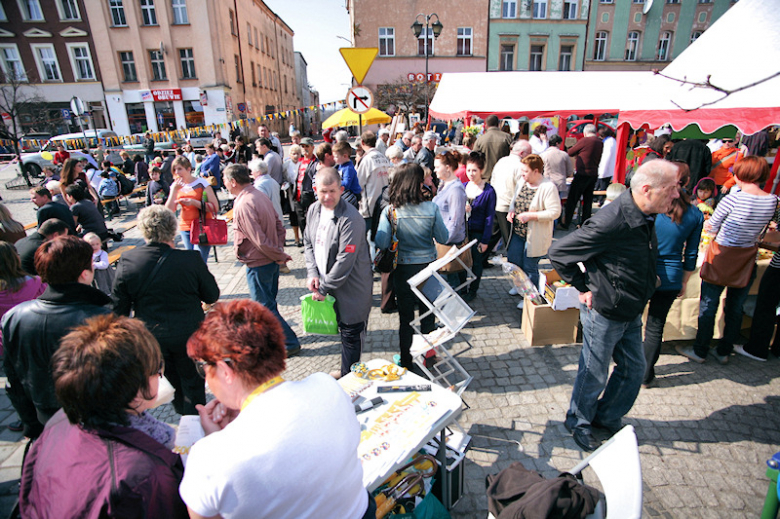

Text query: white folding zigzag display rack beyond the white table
(409, 240), (477, 396)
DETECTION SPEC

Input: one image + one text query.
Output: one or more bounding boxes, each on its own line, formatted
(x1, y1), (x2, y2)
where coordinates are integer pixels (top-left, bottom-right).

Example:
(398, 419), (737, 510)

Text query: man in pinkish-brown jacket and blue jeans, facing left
(223, 164), (301, 357)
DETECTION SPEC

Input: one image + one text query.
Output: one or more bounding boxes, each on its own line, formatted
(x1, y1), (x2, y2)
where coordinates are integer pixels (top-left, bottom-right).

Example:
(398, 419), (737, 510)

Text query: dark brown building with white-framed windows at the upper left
(0, 0), (106, 135)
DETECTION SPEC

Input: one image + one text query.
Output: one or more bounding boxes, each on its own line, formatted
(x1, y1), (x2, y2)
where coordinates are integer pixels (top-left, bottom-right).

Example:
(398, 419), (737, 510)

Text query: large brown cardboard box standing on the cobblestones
(521, 297), (580, 346)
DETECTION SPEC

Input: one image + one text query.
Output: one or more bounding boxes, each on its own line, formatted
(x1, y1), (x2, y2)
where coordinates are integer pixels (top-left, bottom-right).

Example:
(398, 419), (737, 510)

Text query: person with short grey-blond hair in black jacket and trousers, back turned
(111, 205), (219, 414)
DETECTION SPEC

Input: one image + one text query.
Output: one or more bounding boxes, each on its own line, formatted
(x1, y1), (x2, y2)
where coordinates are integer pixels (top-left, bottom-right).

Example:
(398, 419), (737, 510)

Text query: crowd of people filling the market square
(0, 116), (780, 518)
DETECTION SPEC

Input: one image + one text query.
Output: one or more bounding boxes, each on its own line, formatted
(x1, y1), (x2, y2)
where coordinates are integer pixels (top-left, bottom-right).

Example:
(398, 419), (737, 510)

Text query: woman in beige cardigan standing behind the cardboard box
(506, 155), (561, 308)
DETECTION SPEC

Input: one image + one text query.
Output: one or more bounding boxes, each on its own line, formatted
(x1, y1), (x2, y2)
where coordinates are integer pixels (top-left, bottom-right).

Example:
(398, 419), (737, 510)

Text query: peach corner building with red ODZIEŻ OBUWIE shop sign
(80, 0), (298, 135)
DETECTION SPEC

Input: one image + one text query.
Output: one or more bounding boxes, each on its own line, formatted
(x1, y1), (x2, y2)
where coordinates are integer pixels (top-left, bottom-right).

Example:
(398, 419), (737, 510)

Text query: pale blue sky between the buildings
(264, 0), (352, 103)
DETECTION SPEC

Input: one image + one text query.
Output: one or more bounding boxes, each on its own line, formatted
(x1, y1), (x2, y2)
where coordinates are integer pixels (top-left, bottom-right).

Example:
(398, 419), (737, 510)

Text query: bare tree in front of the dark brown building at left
(0, 70), (45, 186)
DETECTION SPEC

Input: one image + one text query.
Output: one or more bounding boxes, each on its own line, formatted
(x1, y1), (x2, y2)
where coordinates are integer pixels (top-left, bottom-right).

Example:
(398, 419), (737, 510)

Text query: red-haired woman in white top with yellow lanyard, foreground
(179, 299), (376, 519)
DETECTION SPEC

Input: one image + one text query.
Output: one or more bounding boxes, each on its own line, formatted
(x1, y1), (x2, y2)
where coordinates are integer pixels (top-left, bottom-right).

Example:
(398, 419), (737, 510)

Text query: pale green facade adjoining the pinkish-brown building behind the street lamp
(488, 0), (592, 71)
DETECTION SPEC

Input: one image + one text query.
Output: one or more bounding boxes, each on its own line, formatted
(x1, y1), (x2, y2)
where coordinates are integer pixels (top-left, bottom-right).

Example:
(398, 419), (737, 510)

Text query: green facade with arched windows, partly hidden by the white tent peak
(585, 0), (736, 70)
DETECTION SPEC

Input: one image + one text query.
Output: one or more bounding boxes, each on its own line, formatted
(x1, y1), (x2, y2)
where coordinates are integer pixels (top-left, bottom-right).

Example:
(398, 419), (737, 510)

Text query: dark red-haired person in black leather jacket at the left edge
(2, 236), (111, 438)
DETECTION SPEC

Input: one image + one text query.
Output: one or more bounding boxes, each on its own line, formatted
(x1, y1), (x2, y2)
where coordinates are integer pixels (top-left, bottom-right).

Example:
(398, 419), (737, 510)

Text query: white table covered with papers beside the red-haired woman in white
(344, 359), (462, 503)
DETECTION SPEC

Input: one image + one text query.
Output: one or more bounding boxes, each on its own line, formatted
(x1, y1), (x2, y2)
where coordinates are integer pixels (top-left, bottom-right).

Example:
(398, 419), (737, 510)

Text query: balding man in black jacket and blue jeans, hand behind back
(547, 160), (679, 451)
